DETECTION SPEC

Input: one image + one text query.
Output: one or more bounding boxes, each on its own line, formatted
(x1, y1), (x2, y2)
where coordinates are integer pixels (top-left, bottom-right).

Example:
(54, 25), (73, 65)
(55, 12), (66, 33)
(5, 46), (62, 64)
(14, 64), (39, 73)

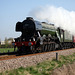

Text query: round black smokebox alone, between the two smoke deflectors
(22, 18), (36, 41)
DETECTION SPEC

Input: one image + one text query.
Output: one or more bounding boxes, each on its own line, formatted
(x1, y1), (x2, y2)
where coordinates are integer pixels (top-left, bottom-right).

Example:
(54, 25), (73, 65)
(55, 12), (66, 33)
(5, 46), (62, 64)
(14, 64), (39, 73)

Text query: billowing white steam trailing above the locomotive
(30, 6), (75, 35)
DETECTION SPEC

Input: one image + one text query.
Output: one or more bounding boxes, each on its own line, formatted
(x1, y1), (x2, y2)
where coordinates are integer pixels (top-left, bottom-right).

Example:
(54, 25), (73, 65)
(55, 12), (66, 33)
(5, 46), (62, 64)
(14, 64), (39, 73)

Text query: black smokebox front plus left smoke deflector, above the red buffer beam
(16, 17), (35, 41)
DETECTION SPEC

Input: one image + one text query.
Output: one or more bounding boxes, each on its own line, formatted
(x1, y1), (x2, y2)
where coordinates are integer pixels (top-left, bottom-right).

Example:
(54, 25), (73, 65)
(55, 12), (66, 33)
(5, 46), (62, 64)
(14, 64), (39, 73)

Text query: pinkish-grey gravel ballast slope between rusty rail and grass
(0, 48), (75, 72)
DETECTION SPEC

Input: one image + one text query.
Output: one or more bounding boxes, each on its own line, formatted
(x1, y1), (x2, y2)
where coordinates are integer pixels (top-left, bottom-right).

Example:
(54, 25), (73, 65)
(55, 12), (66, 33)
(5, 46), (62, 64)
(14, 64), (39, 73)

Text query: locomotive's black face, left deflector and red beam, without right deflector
(14, 17), (36, 48)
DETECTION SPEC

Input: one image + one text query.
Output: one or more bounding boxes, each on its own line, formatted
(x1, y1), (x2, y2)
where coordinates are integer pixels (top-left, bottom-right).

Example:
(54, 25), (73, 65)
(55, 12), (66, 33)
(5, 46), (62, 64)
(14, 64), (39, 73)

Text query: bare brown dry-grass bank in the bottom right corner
(52, 62), (75, 75)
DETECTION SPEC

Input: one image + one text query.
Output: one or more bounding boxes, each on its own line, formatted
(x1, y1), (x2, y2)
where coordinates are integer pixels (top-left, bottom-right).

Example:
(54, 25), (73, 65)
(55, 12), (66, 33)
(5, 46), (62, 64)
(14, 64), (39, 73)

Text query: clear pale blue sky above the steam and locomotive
(0, 0), (75, 40)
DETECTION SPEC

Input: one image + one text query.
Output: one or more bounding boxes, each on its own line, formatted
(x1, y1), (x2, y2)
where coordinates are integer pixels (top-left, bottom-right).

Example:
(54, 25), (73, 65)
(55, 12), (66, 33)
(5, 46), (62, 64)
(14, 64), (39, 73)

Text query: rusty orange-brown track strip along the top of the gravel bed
(0, 48), (75, 61)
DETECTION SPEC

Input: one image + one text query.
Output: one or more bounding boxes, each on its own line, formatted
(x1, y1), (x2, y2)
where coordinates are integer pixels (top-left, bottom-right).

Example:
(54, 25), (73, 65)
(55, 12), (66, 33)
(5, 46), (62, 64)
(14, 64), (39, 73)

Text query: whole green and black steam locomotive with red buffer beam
(13, 17), (75, 54)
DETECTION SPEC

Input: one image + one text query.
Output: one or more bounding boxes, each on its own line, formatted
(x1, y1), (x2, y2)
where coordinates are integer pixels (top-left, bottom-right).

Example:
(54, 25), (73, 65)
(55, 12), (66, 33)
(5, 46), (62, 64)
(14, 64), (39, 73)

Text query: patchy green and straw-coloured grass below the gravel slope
(0, 53), (75, 75)
